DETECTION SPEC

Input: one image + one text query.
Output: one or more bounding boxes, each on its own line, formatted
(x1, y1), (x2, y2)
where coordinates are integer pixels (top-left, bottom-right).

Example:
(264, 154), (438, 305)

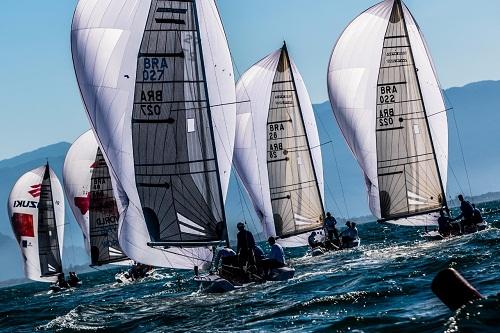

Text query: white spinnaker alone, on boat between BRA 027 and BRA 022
(234, 49), (324, 247)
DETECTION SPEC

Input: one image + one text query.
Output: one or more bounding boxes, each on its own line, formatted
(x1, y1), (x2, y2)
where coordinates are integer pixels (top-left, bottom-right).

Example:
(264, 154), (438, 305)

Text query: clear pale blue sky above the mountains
(0, 0), (500, 160)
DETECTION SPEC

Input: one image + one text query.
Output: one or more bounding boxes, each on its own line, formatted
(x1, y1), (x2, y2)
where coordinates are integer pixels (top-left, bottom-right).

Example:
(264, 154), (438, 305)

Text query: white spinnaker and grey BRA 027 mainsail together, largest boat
(72, 0), (236, 269)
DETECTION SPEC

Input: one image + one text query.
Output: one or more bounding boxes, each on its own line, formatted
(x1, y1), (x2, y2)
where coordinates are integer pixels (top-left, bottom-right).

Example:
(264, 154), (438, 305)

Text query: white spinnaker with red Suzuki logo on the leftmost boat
(8, 166), (64, 282)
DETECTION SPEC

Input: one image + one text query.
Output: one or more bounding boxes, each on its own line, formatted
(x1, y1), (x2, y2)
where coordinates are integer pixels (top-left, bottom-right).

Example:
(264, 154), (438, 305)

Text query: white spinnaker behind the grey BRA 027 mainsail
(72, 0), (236, 269)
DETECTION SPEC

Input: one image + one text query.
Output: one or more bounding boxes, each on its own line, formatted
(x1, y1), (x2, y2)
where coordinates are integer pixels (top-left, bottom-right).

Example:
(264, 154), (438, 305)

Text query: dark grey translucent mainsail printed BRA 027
(132, 0), (225, 246)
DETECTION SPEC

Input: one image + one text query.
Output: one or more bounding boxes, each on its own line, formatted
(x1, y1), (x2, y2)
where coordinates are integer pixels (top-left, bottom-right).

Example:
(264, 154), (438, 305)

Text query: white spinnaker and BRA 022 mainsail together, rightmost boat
(328, 0), (448, 226)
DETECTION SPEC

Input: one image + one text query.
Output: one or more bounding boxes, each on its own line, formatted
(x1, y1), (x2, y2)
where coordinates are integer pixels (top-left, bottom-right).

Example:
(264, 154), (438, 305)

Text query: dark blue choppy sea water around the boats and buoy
(0, 203), (500, 332)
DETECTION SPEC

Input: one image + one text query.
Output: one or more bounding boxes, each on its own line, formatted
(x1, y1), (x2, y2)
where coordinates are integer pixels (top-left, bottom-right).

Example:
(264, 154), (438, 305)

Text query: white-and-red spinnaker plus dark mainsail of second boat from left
(63, 131), (130, 266)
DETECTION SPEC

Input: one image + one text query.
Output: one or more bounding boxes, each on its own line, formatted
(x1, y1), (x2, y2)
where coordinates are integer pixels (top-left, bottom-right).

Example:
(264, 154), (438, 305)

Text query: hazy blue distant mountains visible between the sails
(0, 81), (500, 281)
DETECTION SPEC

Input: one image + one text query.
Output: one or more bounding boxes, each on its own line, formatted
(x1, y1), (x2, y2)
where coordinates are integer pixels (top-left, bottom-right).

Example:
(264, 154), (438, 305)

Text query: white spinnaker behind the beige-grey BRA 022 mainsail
(328, 0), (448, 226)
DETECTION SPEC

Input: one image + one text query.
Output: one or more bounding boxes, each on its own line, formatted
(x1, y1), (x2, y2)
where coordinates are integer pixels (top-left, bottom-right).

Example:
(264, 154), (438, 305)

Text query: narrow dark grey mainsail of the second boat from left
(89, 148), (128, 266)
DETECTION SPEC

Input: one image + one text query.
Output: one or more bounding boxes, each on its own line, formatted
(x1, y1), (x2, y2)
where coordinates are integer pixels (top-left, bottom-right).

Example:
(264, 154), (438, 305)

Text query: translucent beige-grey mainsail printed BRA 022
(376, 1), (446, 219)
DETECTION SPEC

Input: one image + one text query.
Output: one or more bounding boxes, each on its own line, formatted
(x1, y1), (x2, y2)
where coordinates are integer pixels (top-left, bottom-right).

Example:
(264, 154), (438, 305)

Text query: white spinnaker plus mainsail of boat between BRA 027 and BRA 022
(235, 47), (324, 246)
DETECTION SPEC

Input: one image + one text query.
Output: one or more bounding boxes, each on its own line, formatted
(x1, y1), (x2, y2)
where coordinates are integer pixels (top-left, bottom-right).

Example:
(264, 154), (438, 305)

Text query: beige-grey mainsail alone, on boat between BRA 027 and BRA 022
(267, 46), (323, 238)
